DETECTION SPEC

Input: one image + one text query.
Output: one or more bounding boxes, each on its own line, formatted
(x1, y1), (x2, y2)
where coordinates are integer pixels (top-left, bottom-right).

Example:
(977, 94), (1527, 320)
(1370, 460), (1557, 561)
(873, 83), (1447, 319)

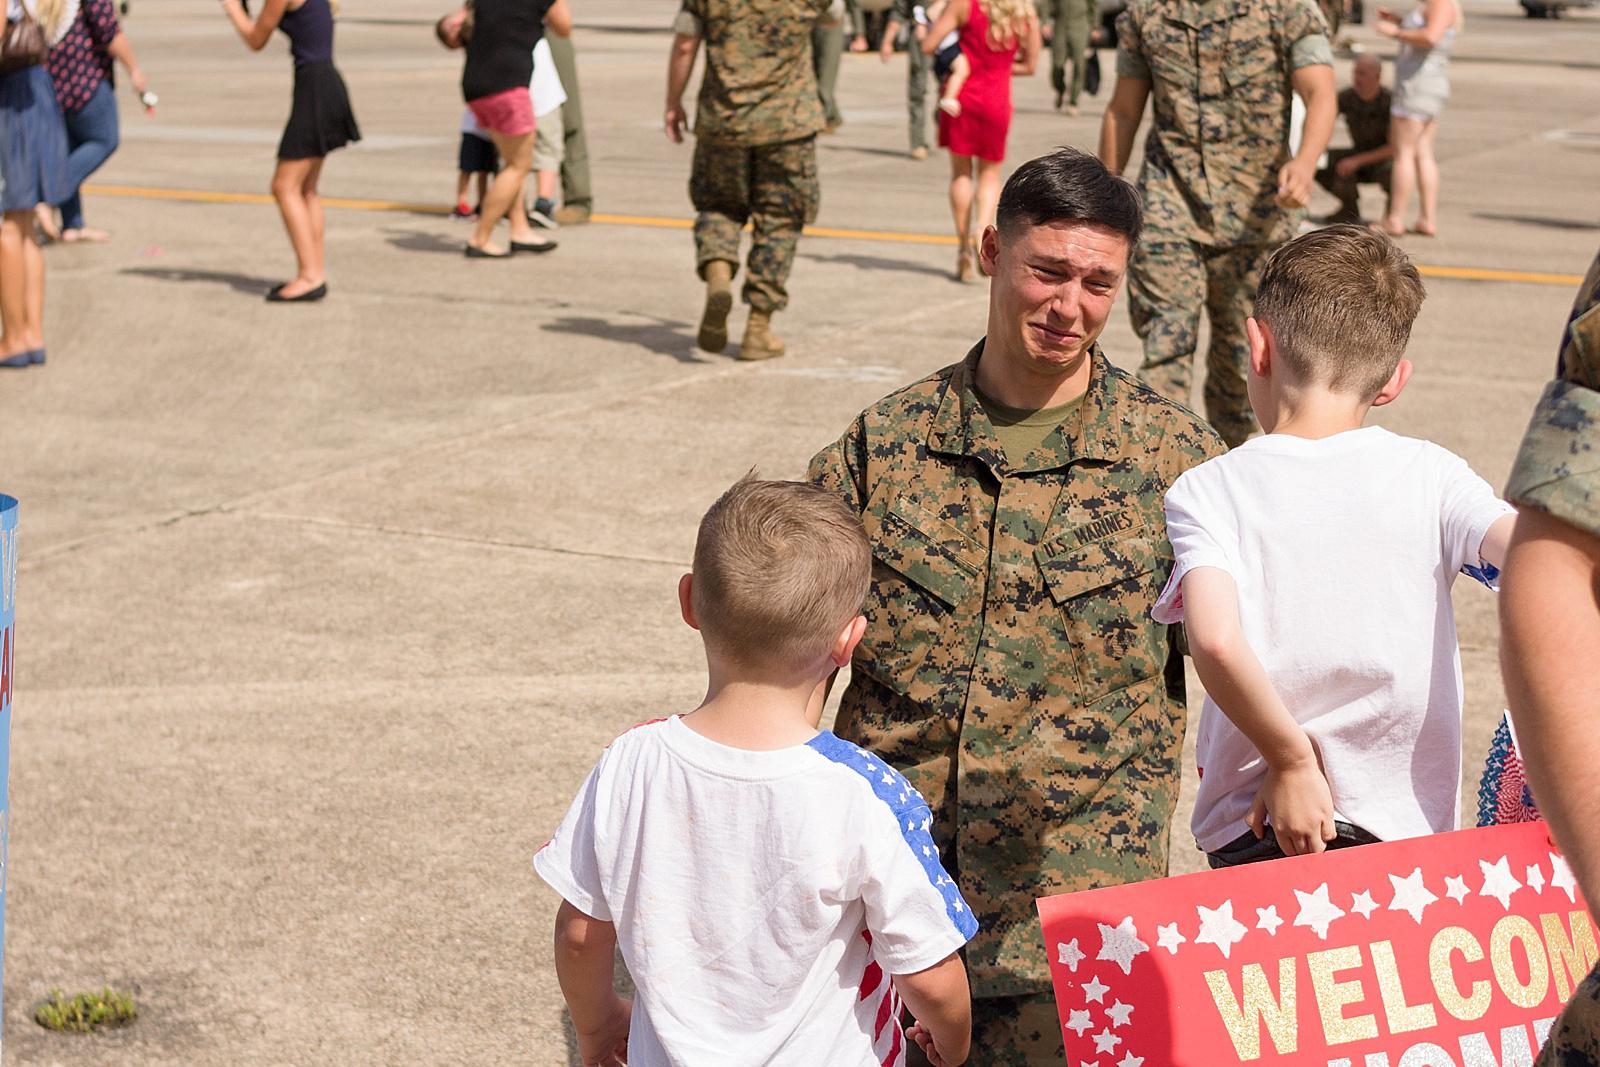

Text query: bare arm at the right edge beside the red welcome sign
(1499, 509), (1600, 912)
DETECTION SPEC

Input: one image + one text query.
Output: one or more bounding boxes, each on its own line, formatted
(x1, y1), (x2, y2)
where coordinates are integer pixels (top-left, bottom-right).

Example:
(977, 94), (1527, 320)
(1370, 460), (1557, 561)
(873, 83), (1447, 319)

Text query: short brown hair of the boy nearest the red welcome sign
(1256, 224), (1427, 400)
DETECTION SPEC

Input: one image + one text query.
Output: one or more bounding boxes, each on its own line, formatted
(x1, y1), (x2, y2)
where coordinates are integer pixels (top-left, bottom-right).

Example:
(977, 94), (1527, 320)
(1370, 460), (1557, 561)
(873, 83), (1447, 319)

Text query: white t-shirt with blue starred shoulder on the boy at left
(534, 715), (978, 1067)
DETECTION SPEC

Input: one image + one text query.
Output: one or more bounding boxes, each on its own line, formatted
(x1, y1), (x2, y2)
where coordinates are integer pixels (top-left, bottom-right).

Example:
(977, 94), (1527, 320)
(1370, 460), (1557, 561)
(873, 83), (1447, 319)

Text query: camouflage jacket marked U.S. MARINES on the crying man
(810, 342), (1222, 997)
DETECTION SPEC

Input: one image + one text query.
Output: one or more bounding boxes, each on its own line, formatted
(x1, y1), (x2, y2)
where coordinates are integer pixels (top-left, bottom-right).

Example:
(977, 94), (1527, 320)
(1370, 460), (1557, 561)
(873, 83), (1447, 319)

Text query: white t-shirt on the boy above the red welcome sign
(1152, 427), (1512, 851)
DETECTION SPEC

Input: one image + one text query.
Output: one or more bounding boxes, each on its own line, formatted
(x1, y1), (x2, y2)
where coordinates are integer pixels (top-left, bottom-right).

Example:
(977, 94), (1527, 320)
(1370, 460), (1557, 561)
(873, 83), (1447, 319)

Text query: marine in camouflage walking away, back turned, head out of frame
(667, 0), (842, 337)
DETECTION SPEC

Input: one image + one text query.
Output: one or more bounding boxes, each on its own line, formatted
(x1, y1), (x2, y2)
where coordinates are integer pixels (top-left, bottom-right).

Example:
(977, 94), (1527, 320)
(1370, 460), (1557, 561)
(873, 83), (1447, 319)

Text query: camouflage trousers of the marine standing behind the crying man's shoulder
(1128, 240), (1272, 448)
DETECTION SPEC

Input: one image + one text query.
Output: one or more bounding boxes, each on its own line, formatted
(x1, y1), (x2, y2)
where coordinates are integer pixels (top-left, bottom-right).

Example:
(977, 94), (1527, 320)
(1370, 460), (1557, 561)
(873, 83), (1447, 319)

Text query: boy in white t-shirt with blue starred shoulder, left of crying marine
(534, 478), (978, 1067)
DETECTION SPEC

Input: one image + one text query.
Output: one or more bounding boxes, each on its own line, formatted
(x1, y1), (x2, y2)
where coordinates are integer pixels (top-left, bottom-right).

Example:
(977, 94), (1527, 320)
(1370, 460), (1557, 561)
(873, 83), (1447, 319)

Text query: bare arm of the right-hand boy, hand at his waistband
(1182, 566), (1334, 856)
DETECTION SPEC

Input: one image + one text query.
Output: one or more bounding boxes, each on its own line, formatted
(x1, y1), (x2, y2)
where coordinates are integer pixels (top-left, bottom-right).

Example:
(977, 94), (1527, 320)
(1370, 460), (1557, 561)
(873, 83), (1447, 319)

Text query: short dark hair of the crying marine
(995, 147), (1144, 248)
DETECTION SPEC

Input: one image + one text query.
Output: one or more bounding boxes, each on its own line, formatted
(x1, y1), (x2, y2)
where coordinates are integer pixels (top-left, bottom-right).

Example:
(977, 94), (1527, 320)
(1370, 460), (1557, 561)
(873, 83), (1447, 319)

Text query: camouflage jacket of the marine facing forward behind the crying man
(1117, 0), (1333, 245)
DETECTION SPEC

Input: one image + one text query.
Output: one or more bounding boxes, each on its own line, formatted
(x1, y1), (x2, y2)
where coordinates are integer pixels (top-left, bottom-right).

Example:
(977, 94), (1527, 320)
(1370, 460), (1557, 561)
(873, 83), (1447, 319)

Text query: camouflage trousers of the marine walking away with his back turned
(690, 138), (822, 312)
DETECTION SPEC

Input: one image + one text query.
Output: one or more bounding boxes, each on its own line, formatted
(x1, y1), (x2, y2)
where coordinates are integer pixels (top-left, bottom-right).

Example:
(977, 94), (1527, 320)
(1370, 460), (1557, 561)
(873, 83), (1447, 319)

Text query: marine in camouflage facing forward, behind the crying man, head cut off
(1101, 0), (1333, 445)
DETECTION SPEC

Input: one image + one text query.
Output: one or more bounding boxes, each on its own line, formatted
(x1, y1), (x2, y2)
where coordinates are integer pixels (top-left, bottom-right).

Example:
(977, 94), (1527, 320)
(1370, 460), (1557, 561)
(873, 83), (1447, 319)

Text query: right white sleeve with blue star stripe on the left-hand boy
(861, 784), (978, 974)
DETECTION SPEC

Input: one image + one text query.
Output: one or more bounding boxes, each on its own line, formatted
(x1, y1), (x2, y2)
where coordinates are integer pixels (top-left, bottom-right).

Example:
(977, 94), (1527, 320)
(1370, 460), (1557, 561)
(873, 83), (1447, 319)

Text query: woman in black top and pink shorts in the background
(454, 0), (573, 259)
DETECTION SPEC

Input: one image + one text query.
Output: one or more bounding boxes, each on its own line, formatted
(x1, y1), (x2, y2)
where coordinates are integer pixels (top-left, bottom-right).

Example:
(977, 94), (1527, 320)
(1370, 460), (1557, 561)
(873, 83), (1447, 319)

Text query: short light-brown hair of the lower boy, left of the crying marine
(693, 474), (872, 669)
